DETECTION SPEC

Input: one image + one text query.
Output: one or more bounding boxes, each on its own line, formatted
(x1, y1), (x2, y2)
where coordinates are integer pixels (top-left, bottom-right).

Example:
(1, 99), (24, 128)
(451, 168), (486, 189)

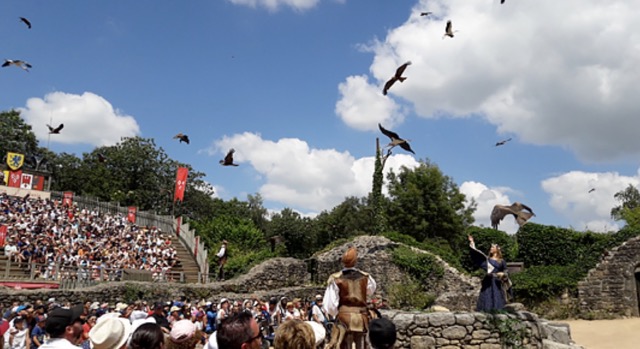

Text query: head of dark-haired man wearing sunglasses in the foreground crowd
(216, 312), (262, 349)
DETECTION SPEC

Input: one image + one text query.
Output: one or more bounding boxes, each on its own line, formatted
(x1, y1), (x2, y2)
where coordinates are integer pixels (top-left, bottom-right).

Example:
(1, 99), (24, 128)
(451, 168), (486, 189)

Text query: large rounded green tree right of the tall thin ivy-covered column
(387, 160), (476, 248)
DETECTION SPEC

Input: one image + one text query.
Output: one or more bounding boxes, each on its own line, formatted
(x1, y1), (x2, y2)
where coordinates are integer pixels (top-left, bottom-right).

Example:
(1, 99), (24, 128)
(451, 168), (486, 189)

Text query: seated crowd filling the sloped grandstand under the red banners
(0, 194), (179, 281)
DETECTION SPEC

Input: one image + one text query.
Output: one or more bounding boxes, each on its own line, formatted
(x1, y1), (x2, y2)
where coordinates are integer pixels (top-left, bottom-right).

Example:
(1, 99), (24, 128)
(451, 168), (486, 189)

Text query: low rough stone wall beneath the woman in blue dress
(382, 311), (581, 349)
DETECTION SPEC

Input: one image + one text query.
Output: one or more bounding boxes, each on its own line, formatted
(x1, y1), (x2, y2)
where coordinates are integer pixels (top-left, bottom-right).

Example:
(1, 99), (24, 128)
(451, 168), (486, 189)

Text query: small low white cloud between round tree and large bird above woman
(460, 181), (524, 234)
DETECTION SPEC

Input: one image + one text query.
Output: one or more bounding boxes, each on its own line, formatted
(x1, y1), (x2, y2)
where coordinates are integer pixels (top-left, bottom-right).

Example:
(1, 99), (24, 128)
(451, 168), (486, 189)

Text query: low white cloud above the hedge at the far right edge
(542, 171), (640, 231)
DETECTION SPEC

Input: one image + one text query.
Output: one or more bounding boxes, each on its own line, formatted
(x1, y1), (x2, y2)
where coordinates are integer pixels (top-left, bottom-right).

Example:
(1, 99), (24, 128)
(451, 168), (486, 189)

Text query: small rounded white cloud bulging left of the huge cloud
(335, 75), (404, 131)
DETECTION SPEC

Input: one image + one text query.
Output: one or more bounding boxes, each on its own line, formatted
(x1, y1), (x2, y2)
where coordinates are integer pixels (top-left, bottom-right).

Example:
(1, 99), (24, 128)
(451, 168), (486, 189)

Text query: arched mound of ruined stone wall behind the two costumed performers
(314, 236), (481, 310)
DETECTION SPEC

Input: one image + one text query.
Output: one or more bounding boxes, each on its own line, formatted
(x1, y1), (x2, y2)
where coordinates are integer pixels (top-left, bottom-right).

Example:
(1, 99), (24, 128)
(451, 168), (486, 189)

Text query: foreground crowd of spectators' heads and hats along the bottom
(0, 297), (395, 349)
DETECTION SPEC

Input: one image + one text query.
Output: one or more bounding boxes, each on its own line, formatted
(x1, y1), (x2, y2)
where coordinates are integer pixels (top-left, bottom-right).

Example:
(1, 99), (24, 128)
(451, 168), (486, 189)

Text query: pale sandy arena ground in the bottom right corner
(558, 318), (640, 349)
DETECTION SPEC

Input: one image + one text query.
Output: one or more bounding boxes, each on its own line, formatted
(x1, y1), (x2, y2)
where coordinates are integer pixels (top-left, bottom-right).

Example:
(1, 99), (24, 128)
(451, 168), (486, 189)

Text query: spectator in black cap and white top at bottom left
(40, 304), (84, 349)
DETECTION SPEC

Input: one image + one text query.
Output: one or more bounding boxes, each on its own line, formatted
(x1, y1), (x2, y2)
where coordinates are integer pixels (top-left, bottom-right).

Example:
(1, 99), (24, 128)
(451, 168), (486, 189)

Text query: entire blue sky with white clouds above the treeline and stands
(0, 0), (640, 232)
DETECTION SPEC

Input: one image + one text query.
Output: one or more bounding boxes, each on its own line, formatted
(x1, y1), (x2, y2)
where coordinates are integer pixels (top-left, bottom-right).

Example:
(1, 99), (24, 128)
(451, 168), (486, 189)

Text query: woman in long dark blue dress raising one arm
(469, 235), (511, 312)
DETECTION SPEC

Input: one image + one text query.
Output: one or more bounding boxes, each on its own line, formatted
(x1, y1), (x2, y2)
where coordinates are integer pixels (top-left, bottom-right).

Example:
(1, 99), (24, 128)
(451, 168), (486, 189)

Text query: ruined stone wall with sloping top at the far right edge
(578, 236), (640, 317)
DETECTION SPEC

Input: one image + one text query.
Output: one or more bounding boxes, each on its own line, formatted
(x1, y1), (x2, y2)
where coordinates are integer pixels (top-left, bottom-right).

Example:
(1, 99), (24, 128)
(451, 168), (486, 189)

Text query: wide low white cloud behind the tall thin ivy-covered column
(208, 132), (418, 212)
